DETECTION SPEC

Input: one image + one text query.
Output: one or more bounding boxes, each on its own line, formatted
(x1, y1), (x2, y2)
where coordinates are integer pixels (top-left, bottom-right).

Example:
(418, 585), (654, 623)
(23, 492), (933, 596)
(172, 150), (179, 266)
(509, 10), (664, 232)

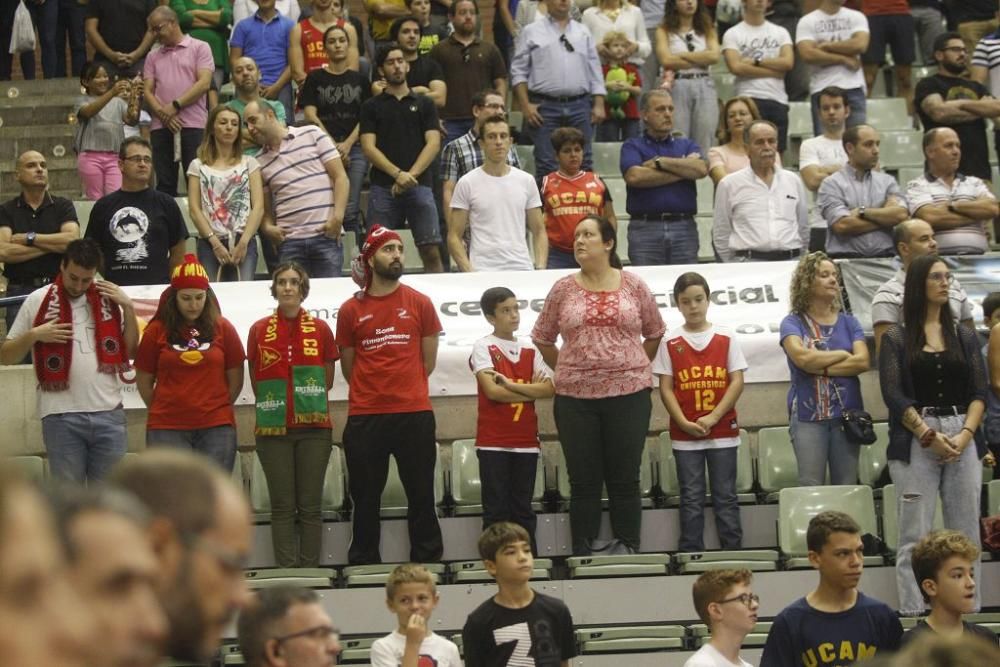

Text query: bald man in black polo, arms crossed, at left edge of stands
(0, 151), (80, 331)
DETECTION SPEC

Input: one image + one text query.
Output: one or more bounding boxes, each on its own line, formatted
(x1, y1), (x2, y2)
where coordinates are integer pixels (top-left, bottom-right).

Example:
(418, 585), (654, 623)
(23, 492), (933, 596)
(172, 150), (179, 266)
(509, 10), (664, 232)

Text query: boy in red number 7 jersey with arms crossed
(469, 287), (555, 543)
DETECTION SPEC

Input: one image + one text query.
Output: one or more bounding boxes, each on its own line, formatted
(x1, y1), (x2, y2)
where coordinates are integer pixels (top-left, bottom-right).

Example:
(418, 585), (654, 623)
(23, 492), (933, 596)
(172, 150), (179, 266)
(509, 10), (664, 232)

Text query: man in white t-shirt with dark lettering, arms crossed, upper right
(722, 0), (795, 153)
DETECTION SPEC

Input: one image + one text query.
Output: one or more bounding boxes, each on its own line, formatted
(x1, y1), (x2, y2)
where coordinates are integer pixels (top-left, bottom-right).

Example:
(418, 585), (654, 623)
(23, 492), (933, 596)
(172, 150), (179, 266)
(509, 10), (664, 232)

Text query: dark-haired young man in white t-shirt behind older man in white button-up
(799, 86), (851, 252)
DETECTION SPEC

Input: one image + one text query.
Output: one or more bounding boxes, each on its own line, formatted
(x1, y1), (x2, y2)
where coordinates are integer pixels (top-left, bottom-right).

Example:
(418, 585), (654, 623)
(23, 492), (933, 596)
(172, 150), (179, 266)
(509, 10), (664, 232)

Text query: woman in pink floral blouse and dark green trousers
(531, 216), (666, 555)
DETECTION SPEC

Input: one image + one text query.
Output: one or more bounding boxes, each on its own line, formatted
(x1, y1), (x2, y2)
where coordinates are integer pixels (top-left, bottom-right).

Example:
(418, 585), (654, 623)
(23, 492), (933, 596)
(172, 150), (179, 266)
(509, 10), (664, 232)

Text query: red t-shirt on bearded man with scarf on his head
(337, 284), (442, 416)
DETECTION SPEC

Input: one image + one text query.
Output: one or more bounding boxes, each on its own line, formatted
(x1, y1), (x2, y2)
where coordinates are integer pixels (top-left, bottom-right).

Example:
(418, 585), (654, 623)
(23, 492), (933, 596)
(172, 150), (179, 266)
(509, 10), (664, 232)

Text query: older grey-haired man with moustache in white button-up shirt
(712, 120), (809, 262)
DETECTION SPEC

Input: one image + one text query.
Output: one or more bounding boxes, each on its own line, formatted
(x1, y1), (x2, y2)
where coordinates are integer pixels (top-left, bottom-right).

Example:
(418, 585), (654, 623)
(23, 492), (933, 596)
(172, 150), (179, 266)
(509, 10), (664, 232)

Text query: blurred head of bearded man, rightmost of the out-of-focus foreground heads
(109, 449), (251, 663)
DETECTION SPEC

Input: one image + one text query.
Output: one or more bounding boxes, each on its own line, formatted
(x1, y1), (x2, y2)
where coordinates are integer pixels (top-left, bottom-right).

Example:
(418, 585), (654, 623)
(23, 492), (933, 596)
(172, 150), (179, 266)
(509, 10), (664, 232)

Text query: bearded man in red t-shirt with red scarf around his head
(337, 224), (444, 565)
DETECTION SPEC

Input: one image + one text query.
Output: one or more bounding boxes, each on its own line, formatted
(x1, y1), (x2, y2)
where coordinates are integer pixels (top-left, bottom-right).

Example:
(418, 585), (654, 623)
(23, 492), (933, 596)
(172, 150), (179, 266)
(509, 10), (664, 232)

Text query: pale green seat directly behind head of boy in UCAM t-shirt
(778, 485), (883, 569)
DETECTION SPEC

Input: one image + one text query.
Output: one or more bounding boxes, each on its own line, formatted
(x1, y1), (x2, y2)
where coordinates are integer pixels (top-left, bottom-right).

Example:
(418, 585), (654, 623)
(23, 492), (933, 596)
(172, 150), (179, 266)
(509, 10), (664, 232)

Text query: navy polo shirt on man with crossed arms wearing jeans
(619, 134), (702, 218)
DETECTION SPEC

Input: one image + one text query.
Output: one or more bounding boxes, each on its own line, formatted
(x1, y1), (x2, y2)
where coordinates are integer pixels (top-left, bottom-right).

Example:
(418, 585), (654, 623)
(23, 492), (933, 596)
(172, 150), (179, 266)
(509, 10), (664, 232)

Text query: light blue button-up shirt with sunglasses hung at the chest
(510, 16), (607, 97)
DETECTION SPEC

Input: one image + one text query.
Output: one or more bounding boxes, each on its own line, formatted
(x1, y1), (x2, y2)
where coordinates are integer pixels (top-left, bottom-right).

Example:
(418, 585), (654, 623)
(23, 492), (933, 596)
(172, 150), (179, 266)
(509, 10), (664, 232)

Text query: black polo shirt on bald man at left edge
(0, 194), (78, 285)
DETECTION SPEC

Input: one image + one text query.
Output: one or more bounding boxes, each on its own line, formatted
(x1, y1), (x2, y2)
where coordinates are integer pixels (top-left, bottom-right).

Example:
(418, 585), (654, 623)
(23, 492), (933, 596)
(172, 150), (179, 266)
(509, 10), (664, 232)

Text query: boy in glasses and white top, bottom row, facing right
(684, 569), (760, 667)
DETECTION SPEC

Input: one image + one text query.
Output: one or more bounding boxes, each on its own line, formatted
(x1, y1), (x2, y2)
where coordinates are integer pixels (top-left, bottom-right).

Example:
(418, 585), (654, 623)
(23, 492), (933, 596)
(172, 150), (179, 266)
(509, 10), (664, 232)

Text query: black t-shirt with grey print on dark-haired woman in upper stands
(299, 68), (371, 142)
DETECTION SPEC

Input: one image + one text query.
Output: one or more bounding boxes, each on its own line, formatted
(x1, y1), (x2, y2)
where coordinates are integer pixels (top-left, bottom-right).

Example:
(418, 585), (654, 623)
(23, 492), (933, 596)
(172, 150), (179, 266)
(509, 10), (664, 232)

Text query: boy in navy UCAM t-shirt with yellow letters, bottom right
(760, 512), (903, 667)
